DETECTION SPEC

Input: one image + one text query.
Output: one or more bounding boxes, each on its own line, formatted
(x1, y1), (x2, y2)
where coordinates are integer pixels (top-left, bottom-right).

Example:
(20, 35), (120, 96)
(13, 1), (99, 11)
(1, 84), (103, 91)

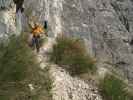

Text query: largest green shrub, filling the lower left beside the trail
(0, 35), (51, 100)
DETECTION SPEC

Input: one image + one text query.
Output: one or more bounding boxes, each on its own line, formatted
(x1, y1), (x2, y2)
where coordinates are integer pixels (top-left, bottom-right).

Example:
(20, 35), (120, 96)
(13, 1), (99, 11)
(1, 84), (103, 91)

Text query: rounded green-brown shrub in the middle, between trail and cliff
(50, 37), (96, 75)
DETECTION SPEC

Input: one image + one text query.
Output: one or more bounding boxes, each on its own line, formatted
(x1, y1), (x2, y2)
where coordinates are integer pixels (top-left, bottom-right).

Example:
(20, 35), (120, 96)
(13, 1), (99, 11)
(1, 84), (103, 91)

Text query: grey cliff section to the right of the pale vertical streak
(62, 0), (133, 80)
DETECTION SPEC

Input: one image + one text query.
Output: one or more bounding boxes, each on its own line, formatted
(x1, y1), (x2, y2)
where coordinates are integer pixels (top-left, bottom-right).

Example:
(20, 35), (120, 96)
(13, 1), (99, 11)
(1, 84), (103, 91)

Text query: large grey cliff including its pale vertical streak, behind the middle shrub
(24, 0), (133, 80)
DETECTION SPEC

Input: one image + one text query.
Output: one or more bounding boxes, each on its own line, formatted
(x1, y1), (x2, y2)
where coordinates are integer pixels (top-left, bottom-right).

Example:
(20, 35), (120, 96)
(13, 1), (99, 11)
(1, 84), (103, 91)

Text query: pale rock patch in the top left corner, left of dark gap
(0, 0), (16, 41)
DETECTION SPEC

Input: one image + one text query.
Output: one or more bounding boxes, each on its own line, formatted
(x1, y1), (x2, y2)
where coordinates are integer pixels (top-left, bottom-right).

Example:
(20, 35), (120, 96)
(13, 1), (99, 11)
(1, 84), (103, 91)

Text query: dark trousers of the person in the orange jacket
(32, 36), (40, 52)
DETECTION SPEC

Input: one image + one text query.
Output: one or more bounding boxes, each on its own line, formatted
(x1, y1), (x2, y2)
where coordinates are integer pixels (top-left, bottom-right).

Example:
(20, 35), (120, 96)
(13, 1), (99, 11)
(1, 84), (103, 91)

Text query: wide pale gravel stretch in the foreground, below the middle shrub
(50, 65), (102, 100)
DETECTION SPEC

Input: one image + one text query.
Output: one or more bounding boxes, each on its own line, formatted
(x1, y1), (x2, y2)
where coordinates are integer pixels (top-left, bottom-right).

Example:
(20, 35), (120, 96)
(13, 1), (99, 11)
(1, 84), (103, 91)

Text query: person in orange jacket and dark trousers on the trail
(31, 23), (44, 52)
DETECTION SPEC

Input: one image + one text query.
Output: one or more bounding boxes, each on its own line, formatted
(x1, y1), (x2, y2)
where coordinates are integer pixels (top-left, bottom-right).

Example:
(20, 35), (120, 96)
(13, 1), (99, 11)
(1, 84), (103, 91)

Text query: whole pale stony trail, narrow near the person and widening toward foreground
(37, 38), (102, 100)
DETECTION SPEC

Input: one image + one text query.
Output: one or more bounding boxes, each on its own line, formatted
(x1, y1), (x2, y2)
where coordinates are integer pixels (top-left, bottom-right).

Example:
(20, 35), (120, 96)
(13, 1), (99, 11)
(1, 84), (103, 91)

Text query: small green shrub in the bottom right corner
(100, 75), (133, 100)
